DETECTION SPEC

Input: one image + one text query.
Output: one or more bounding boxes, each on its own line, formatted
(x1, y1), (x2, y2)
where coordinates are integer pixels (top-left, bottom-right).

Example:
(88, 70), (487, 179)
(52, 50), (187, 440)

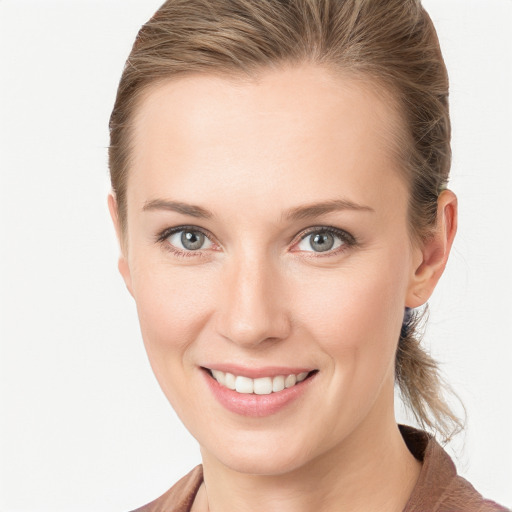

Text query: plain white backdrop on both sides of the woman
(0, 0), (512, 512)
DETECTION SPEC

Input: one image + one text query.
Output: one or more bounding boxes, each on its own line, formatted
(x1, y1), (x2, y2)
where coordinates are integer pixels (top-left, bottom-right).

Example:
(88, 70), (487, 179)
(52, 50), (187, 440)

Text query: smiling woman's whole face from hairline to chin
(111, 66), (432, 474)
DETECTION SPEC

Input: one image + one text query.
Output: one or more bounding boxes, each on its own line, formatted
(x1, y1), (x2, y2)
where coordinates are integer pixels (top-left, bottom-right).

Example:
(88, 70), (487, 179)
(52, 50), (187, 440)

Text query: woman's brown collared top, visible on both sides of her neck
(133, 425), (510, 512)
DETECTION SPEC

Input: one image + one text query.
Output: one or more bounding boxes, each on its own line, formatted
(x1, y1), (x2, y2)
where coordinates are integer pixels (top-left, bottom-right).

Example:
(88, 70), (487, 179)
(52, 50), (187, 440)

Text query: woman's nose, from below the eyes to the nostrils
(217, 258), (290, 347)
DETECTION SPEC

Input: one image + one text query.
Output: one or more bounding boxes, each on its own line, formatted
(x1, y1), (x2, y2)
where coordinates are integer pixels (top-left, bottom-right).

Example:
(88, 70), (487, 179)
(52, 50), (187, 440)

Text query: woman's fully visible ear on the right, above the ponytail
(405, 190), (457, 308)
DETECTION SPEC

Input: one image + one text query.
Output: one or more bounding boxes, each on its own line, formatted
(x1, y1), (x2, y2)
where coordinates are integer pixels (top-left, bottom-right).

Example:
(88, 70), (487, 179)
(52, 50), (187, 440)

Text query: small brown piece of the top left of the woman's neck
(132, 465), (203, 512)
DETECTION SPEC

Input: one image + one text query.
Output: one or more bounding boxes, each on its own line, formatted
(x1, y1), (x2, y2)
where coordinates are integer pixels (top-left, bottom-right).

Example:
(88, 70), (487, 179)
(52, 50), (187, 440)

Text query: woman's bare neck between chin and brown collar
(192, 406), (421, 512)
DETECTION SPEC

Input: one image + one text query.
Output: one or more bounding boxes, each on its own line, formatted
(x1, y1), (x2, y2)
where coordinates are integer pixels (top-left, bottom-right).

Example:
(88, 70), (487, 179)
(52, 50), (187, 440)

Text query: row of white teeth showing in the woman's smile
(211, 370), (309, 395)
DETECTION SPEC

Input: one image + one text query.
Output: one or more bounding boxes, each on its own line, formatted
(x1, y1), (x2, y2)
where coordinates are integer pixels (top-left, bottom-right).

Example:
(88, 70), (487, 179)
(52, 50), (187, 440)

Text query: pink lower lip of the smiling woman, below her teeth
(202, 370), (316, 418)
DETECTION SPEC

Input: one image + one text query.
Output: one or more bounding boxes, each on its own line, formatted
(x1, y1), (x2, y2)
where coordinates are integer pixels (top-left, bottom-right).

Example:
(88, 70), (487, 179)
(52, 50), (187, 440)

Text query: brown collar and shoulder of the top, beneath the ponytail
(400, 425), (507, 512)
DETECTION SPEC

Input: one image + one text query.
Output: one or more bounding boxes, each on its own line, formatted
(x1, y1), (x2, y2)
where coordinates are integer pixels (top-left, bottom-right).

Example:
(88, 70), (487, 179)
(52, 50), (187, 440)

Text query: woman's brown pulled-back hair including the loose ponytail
(109, 0), (461, 438)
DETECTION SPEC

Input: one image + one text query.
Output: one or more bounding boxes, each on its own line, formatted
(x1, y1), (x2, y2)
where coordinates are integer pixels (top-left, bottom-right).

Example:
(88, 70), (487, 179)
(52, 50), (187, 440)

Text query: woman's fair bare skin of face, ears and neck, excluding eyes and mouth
(109, 65), (456, 512)
